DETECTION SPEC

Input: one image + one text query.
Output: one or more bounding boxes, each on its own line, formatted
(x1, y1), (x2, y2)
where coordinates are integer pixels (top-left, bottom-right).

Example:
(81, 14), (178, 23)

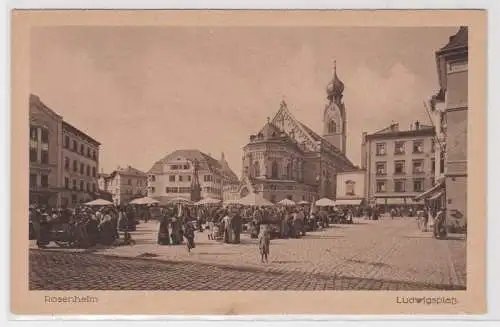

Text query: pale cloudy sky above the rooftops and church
(31, 26), (458, 175)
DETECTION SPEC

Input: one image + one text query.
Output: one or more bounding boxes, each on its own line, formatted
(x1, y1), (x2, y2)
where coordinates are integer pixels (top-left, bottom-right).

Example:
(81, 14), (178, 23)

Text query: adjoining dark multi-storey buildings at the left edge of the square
(29, 94), (100, 207)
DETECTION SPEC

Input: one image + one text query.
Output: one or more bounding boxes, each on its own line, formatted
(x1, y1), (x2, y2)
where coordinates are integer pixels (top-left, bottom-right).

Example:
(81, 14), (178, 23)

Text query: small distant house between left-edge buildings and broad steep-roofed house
(99, 166), (148, 205)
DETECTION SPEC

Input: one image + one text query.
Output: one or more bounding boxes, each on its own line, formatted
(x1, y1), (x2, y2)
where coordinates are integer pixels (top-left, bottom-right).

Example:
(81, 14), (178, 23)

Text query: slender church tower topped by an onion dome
(323, 62), (346, 154)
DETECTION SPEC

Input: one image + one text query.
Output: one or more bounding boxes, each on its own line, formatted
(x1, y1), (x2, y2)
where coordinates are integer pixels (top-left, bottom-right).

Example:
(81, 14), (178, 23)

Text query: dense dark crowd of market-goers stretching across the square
(30, 200), (438, 254)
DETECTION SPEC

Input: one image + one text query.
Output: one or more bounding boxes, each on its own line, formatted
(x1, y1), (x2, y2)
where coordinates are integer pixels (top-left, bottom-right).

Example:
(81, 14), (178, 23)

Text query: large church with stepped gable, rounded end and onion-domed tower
(234, 62), (356, 202)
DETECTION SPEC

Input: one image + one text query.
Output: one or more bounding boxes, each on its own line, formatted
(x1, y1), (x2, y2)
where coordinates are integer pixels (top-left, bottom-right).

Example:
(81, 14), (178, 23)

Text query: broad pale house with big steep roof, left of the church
(147, 149), (238, 203)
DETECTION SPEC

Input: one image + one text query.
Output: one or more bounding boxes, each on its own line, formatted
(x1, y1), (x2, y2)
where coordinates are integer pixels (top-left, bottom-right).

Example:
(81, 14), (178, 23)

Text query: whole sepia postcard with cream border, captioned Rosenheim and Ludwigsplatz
(11, 10), (487, 315)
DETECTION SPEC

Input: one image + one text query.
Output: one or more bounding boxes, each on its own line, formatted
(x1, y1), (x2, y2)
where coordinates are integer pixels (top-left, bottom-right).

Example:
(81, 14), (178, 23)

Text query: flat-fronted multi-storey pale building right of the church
(361, 121), (435, 208)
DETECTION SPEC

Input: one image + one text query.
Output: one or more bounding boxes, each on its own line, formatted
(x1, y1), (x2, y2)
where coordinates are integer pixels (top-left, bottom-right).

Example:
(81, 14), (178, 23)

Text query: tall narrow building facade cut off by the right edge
(433, 27), (469, 228)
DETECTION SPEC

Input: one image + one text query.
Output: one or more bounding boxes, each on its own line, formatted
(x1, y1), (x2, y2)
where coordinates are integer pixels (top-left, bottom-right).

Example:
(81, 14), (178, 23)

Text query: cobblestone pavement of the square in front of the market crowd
(30, 218), (466, 290)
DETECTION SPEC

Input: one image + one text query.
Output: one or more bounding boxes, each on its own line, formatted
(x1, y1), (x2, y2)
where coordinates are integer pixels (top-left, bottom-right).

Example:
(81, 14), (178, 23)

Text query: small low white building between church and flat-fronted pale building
(335, 169), (366, 205)
